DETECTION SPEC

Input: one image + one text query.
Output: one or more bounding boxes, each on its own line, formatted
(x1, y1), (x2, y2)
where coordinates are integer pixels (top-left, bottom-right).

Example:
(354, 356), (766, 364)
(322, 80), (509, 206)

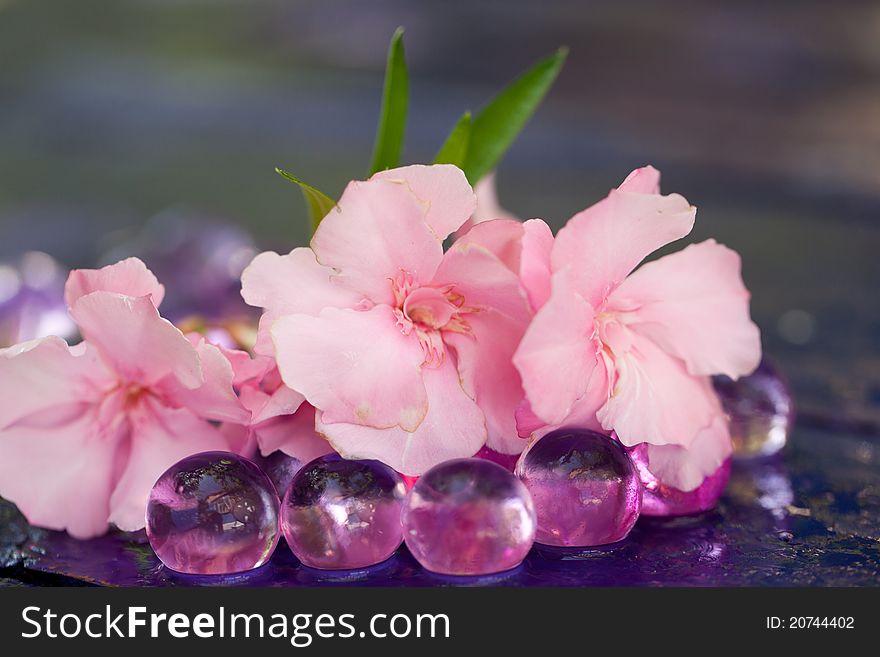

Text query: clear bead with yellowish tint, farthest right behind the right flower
(713, 360), (794, 458)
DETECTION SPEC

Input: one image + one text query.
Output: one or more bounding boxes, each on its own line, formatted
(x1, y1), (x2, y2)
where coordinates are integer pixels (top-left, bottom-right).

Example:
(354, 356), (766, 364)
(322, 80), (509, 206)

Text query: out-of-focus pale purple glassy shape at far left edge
(0, 251), (76, 348)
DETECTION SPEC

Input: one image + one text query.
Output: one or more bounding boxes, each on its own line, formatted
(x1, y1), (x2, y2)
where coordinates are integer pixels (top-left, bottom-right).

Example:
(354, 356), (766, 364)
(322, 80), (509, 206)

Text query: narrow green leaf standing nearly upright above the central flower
(370, 27), (409, 175)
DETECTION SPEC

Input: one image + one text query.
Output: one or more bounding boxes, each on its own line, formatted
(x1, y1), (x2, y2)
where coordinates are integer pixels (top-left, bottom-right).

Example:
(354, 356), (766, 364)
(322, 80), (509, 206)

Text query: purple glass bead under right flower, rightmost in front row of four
(516, 429), (642, 547)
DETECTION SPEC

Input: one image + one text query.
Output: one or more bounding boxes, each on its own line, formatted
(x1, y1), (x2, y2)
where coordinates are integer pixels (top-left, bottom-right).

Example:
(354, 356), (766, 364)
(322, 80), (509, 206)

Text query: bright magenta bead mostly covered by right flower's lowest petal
(629, 443), (731, 516)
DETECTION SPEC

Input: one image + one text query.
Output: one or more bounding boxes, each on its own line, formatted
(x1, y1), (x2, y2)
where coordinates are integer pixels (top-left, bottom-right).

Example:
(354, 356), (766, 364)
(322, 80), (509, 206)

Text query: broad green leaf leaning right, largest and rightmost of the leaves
(463, 48), (568, 185)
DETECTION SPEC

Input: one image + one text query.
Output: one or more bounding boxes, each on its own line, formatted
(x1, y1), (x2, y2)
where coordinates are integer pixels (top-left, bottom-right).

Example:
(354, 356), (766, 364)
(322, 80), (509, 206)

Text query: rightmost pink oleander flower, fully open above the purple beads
(514, 167), (761, 491)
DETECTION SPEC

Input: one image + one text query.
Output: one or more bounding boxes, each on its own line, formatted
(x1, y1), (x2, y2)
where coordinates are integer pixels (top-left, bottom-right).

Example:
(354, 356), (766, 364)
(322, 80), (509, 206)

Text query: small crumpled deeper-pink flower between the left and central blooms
(222, 349), (333, 464)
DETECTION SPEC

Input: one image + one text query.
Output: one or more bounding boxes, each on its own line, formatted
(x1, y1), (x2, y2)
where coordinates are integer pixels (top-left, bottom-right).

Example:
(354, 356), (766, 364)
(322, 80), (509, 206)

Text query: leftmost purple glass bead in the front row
(147, 452), (280, 575)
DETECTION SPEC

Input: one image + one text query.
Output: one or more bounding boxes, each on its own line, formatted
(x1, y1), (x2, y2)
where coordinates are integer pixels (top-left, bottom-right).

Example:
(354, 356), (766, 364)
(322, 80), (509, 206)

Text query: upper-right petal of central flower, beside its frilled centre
(433, 239), (531, 322)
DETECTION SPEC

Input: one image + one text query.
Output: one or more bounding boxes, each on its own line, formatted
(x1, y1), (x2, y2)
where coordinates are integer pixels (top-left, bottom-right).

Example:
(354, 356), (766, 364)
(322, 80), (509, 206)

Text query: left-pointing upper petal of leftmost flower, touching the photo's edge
(0, 337), (114, 430)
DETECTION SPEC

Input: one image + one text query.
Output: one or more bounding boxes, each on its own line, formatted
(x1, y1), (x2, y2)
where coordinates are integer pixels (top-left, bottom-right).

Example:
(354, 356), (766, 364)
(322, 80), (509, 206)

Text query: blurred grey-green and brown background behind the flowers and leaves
(0, 0), (880, 432)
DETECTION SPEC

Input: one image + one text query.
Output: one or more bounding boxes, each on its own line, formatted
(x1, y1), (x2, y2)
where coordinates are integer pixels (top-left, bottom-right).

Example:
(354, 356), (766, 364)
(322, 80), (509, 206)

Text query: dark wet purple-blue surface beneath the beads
(0, 426), (880, 586)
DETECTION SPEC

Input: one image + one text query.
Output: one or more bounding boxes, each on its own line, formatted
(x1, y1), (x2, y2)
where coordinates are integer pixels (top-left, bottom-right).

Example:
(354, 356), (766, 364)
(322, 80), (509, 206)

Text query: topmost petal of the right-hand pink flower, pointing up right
(551, 169), (696, 308)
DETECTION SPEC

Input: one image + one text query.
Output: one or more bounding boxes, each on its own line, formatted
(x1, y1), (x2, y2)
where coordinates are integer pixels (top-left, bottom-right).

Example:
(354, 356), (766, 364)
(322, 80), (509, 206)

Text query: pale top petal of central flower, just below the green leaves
(370, 164), (477, 242)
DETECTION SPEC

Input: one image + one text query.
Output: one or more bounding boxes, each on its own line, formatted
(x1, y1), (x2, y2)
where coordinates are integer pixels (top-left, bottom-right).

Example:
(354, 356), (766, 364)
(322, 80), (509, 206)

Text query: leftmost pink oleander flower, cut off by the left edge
(0, 258), (250, 538)
